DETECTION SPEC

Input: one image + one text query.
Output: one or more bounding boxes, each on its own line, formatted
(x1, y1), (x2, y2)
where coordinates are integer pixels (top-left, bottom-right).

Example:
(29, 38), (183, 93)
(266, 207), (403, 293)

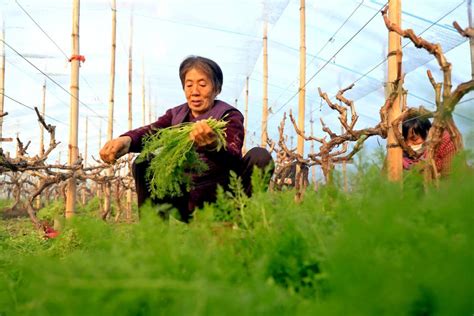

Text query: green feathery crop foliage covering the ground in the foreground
(0, 157), (474, 316)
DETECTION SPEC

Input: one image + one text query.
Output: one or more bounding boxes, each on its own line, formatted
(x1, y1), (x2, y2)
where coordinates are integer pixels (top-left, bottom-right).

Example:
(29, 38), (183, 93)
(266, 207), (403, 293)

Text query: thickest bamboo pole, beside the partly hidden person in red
(387, 0), (403, 181)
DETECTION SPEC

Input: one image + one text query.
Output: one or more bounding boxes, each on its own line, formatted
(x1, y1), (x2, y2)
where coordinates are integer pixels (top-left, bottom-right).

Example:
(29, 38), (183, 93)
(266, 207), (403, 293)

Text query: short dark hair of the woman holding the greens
(179, 55), (224, 94)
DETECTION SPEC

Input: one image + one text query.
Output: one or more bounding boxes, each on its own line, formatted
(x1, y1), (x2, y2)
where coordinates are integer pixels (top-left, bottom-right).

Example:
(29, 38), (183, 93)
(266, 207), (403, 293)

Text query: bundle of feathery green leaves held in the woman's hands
(138, 118), (227, 199)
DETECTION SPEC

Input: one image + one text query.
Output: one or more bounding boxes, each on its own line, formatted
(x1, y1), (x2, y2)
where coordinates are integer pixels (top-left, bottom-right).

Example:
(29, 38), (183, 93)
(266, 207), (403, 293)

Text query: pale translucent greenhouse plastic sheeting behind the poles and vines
(0, 0), (474, 162)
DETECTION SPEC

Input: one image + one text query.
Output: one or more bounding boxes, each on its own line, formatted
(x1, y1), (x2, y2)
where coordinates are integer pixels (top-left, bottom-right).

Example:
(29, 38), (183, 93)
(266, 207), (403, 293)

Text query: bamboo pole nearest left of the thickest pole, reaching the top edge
(297, 0), (306, 157)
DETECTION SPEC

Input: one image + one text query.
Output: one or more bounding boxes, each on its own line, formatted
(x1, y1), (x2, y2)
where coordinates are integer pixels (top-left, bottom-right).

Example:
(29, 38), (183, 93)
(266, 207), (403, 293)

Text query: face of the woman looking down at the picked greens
(184, 68), (216, 117)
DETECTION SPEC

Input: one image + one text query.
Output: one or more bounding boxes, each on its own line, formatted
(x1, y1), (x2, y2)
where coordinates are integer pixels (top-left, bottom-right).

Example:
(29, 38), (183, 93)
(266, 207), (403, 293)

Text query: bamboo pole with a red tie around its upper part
(66, 0), (80, 218)
